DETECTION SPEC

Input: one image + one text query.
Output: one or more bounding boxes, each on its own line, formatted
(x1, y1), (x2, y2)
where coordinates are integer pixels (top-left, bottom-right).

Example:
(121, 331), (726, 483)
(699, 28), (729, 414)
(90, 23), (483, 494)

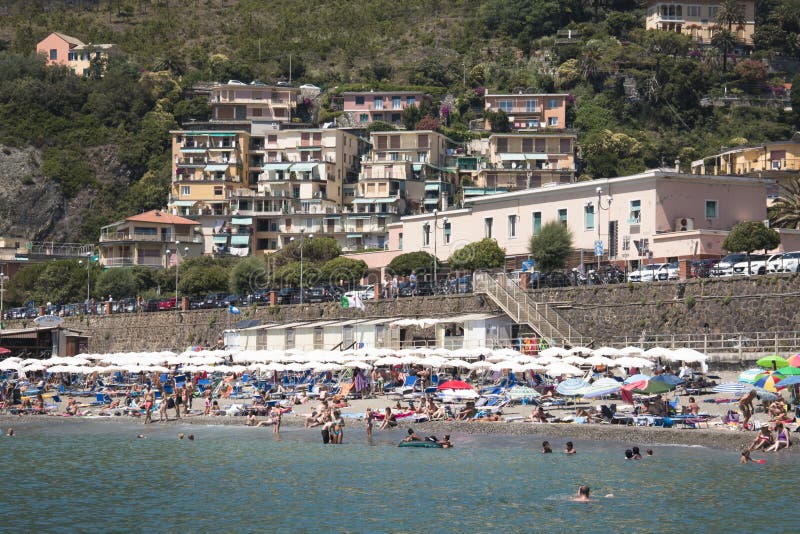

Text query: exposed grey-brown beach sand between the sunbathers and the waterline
(0, 371), (800, 451)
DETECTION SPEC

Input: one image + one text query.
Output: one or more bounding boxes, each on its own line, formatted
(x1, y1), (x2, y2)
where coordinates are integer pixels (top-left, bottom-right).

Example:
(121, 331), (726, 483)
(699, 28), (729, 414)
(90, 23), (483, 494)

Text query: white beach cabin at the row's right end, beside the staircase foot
(436, 313), (512, 349)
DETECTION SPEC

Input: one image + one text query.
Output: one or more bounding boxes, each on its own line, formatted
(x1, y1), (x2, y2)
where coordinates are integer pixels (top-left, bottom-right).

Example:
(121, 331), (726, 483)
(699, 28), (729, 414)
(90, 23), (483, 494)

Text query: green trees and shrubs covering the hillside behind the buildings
(0, 0), (800, 242)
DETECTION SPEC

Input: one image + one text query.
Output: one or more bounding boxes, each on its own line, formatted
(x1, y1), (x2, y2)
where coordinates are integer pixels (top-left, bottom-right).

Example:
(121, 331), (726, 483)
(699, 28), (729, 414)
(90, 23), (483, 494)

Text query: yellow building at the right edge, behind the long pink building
(692, 132), (800, 178)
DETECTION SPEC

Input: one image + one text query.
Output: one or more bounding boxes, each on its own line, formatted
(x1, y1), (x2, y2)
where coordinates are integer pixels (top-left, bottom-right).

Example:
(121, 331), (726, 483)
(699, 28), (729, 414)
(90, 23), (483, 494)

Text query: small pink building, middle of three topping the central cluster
(342, 91), (431, 124)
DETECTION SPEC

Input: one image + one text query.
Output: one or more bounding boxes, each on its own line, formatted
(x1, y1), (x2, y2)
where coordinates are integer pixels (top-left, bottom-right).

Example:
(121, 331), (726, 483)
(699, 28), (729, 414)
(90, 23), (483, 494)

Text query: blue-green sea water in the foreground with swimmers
(0, 422), (800, 532)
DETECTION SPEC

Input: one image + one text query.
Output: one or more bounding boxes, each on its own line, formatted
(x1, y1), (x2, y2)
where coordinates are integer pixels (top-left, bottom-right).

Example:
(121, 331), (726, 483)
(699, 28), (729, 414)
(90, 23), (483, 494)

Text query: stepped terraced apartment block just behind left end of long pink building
(358, 130), (455, 214)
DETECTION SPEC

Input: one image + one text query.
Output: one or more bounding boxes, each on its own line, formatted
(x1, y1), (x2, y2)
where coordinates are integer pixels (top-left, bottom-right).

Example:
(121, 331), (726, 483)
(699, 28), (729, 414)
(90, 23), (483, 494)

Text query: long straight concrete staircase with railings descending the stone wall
(472, 273), (582, 346)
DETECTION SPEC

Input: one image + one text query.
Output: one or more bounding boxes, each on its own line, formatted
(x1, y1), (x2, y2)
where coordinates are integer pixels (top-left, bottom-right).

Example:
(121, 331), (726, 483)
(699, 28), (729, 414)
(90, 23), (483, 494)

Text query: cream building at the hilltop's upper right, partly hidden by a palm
(645, 0), (756, 45)
